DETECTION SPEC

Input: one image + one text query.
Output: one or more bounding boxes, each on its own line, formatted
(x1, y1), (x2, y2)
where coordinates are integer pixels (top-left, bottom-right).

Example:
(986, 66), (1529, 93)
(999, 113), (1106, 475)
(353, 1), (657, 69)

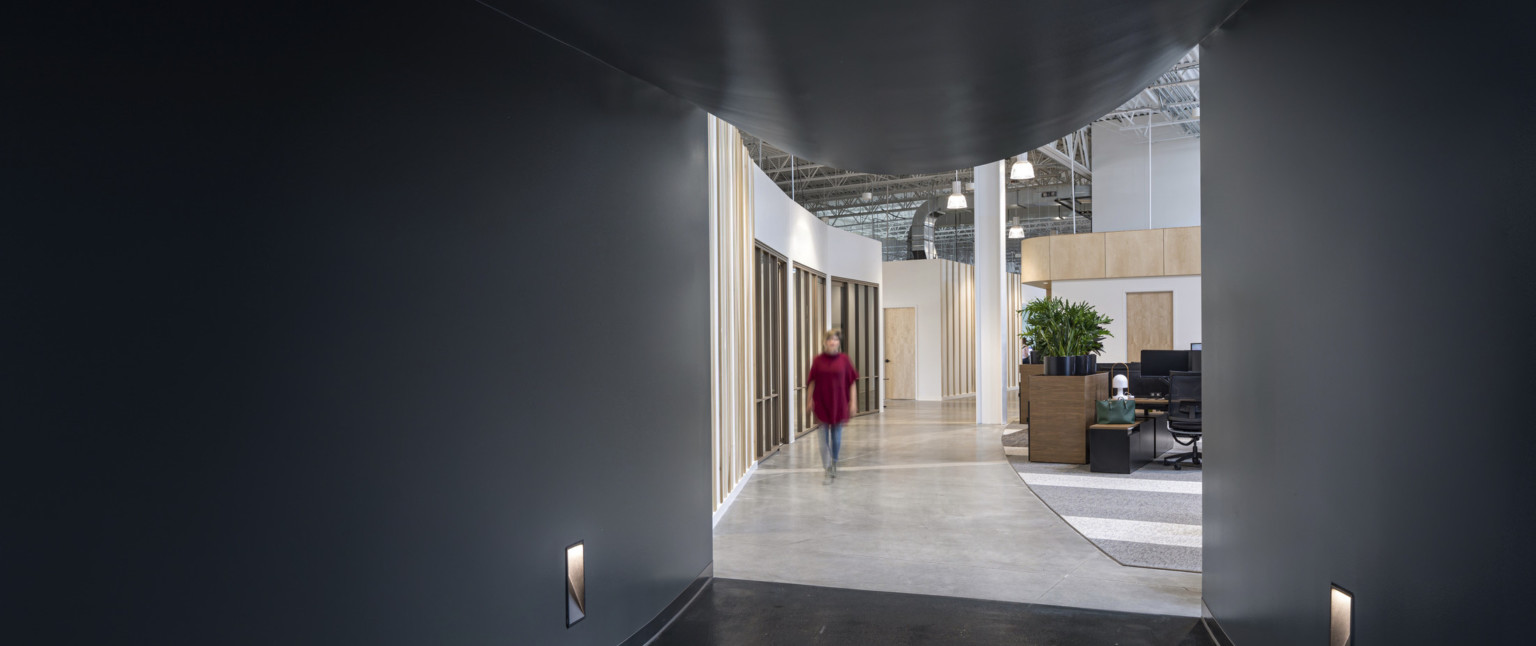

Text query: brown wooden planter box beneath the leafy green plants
(1029, 373), (1109, 465)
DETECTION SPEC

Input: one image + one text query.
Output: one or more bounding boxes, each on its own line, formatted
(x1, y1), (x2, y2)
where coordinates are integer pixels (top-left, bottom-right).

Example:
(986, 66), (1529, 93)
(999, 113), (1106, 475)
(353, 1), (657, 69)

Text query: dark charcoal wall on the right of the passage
(1201, 0), (1536, 646)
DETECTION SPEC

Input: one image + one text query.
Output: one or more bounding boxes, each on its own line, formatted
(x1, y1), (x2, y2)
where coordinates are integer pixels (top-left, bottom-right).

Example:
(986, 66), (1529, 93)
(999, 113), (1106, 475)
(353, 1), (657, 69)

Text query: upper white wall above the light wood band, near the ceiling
(1094, 124), (1200, 232)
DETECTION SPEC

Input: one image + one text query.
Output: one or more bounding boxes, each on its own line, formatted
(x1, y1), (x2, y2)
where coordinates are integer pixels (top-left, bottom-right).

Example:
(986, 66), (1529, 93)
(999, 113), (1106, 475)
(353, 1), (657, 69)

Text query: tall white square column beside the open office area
(974, 161), (1008, 424)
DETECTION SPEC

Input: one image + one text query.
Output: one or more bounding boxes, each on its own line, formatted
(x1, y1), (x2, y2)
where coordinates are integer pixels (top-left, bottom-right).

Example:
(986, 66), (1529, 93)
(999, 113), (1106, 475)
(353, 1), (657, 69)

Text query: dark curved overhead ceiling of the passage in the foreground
(482, 0), (1243, 173)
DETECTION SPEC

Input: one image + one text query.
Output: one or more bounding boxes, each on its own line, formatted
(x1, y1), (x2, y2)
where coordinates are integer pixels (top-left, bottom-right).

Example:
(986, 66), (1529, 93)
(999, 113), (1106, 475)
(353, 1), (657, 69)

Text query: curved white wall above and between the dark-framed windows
(753, 166), (885, 426)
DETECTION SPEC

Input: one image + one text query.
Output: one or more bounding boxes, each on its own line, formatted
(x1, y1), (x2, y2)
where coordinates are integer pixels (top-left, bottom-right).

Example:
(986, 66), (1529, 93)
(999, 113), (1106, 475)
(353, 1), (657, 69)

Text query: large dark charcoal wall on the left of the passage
(0, 2), (711, 644)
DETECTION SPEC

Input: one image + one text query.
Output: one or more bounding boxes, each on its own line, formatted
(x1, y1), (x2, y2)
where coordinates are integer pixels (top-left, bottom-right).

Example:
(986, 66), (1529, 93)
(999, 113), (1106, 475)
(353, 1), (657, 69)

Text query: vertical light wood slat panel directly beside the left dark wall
(710, 117), (757, 509)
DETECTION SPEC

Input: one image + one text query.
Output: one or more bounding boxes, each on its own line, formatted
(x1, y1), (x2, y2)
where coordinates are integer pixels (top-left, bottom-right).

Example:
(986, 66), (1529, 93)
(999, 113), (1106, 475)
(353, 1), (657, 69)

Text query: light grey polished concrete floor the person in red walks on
(714, 400), (1200, 617)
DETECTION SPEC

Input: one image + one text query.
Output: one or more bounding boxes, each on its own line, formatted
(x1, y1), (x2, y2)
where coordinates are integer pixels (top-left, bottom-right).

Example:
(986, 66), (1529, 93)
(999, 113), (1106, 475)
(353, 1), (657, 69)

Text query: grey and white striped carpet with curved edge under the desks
(1003, 431), (1203, 572)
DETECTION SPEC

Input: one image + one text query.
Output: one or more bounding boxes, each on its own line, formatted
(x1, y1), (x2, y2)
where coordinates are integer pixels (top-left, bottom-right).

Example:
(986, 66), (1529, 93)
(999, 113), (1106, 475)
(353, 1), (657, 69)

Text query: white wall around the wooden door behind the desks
(1051, 276), (1201, 364)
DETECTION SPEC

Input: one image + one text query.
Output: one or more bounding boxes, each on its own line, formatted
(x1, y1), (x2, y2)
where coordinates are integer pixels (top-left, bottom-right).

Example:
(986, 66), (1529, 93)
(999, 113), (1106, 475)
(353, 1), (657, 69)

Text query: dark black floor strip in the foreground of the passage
(653, 578), (1215, 646)
